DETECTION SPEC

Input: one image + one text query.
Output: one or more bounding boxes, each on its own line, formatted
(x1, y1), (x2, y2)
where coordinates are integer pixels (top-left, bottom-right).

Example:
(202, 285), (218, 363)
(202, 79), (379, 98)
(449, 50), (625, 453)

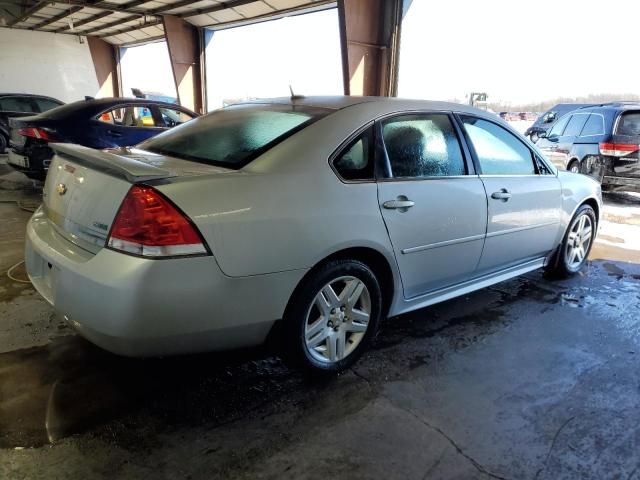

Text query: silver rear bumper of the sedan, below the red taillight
(25, 209), (305, 356)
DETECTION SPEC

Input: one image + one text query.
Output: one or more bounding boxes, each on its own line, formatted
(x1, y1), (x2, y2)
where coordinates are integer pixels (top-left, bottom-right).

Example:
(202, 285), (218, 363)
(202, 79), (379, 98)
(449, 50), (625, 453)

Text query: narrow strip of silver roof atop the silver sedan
(235, 95), (499, 118)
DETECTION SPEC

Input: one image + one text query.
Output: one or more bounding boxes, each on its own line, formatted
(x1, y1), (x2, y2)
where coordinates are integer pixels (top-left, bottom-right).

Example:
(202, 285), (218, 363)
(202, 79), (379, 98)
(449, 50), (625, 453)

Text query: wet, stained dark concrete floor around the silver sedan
(0, 161), (640, 480)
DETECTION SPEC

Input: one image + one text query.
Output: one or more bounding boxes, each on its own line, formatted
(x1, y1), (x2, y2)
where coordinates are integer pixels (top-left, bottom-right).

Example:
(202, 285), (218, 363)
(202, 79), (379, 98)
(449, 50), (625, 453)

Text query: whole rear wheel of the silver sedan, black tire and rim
(284, 260), (382, 372)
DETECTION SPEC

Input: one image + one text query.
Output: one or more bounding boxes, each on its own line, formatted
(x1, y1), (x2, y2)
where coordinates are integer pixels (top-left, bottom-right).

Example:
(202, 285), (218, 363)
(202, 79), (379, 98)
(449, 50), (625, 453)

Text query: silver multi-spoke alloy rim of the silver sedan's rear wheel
(304, 276), (371, 363)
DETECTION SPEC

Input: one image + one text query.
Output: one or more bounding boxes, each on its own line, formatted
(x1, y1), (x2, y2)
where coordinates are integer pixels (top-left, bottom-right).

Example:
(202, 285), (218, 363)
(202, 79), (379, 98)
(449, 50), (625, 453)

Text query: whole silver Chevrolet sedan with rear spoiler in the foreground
(26, 97), (602, 371)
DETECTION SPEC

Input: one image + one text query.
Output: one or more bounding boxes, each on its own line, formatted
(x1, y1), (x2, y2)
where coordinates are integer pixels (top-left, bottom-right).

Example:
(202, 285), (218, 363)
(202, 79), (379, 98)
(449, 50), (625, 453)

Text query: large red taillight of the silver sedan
(107, 185), (208, 257)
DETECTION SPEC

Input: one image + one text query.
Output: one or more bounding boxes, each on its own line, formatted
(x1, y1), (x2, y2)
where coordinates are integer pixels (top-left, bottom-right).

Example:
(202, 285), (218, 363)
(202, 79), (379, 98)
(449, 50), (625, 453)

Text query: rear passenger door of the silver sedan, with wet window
(377, 113), (487, 298)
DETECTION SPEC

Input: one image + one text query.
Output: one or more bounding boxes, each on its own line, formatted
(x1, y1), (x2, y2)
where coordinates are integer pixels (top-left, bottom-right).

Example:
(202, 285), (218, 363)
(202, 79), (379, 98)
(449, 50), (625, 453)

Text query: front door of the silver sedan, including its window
(460, 115), (562, 274)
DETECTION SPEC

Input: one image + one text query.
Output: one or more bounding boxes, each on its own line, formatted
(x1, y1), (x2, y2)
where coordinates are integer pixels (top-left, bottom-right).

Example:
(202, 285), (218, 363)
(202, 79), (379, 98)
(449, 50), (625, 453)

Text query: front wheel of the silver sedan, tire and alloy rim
(546, 205), (597, 278)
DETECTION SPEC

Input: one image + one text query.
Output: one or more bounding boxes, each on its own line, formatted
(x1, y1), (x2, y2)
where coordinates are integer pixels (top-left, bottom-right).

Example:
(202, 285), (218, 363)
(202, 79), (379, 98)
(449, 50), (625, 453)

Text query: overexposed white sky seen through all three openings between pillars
(117, 0), (640, 109)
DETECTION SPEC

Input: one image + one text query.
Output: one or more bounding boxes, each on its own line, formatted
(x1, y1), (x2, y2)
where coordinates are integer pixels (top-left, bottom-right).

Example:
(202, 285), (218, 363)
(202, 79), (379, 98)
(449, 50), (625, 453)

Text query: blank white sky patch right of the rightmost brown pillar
(398, 0), (640, 104)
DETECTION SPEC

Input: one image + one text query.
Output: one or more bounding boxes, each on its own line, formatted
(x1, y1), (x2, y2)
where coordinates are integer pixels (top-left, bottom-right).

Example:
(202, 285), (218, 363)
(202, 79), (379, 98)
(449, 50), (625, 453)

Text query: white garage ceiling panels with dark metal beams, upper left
(0, 0), (335, 46)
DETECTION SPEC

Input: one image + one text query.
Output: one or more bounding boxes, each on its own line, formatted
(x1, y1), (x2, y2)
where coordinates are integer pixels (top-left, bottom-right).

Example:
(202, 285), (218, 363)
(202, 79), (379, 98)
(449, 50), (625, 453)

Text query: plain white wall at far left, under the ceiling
(0, 28), (99, 102)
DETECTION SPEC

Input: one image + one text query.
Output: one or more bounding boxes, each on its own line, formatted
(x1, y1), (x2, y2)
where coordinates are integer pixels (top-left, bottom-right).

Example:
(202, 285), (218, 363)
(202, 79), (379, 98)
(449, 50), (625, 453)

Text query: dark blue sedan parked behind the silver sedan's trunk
(8, 98), (198, 180)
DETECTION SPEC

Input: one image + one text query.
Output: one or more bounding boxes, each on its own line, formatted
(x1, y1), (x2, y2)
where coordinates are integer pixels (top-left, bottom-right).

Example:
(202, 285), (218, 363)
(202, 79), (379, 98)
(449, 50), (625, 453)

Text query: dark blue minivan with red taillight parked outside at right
(536, 102), (640, 192)
